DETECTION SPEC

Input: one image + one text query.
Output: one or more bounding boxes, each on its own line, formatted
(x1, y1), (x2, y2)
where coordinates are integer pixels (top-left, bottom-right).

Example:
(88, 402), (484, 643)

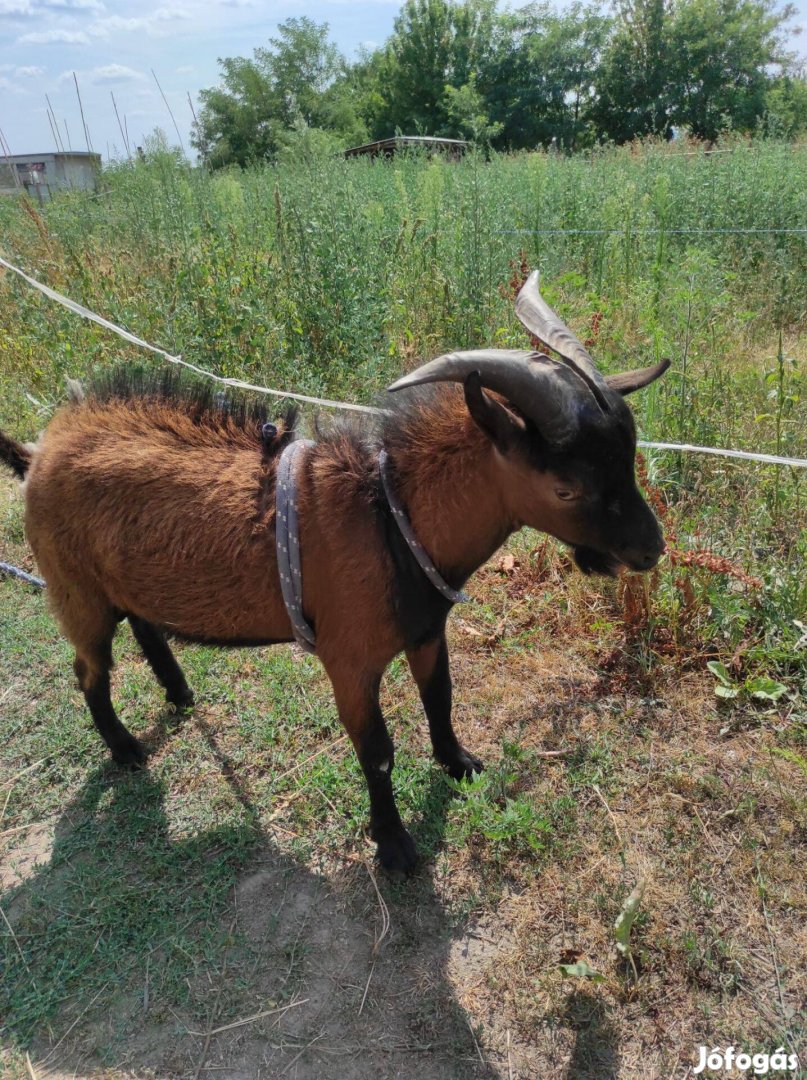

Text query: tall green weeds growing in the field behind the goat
(0, 141), (807, 684)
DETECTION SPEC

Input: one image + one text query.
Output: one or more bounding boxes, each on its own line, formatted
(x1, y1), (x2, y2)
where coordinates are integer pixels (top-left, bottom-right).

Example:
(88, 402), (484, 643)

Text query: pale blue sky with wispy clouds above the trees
(0, 0), (807, 158)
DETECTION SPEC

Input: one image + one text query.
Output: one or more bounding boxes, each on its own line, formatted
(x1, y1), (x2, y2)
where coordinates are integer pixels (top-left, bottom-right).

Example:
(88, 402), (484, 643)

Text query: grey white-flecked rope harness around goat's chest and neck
(274, 438), (468, 653)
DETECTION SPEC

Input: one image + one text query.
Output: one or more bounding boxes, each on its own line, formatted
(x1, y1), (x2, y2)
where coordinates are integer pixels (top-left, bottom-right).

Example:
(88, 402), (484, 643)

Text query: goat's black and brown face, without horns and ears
(506, 393), (664, 575)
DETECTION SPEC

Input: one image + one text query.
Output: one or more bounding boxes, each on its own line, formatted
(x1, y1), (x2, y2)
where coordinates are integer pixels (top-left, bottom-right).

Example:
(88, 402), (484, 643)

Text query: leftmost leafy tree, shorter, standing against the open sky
(192, 17), (363, 165)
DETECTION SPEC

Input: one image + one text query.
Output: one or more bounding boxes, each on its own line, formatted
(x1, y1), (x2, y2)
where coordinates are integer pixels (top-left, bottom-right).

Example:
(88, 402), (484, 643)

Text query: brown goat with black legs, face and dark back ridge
(0, 274), (664, 872)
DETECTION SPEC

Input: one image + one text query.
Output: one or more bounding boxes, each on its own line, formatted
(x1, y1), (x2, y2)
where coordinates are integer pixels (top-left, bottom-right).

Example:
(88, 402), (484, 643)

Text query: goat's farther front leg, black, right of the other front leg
(406, 634), (483, 780)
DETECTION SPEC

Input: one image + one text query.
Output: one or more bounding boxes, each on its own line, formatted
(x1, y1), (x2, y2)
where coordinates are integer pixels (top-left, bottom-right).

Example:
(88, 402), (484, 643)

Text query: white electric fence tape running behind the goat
(0, 256), (807, 469)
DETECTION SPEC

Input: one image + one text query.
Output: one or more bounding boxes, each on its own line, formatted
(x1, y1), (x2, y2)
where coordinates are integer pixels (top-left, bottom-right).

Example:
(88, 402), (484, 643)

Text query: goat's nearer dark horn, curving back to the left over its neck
(389, 349), (595, 443)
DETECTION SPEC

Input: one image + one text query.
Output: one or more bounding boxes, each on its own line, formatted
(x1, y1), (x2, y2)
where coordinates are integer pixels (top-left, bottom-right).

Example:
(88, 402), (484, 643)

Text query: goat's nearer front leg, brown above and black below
(326, 664), (417, 875)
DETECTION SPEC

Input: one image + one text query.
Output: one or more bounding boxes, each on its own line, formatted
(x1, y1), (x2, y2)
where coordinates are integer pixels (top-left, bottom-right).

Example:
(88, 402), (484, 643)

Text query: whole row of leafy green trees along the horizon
(193, 0), (807, 166)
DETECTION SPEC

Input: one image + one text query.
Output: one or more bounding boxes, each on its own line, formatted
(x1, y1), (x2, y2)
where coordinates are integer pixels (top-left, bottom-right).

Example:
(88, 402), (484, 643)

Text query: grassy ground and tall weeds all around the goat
(0, 140), (807, 1080)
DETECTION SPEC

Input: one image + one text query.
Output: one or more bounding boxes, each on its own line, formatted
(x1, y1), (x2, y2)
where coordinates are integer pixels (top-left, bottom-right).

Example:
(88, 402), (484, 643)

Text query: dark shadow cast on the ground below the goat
(0, 712), (498, 1080)
